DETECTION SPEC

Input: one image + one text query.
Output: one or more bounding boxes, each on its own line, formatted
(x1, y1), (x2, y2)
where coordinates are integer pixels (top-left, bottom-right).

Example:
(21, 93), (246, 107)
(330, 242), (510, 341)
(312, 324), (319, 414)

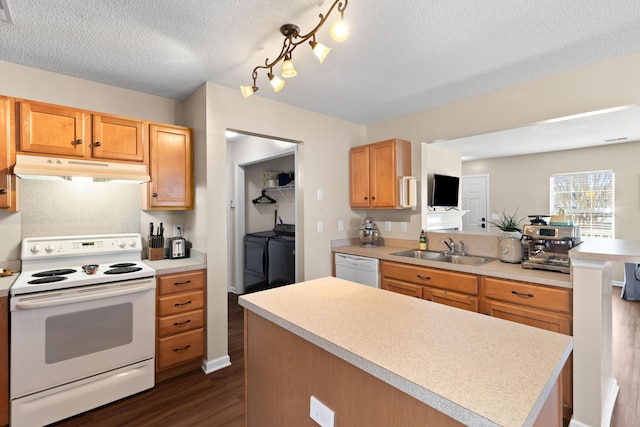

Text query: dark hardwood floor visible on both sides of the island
(55, 287), (640, 427)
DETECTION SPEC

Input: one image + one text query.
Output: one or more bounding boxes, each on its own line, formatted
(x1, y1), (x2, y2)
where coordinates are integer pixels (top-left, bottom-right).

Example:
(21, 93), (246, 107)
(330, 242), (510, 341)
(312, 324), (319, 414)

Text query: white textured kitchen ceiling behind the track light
(0, 0), (640, 157)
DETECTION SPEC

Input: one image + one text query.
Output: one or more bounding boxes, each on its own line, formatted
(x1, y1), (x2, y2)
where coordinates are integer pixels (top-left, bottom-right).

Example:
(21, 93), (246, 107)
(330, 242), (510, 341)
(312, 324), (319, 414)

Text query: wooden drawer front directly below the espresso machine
(483, 277), (571, 313)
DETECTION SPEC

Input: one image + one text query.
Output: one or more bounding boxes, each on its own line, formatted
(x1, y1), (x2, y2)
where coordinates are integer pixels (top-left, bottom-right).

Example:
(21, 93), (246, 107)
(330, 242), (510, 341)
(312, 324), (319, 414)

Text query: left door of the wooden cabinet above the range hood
(17, 101), (90, 157)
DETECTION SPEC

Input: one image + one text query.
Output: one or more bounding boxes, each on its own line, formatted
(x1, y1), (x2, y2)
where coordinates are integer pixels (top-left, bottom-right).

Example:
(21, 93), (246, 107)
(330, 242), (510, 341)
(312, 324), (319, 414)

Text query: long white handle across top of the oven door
(15, 280), (154, 310)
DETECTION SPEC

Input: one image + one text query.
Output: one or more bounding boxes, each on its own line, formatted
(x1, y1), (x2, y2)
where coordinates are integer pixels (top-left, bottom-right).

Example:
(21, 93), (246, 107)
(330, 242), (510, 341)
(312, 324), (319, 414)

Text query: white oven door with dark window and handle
(10, 277), (155, 399)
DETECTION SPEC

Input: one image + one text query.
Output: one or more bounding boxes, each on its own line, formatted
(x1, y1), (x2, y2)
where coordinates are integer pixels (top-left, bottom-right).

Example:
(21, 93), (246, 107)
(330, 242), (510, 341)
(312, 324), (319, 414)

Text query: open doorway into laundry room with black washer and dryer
(227, 131), (303, 294)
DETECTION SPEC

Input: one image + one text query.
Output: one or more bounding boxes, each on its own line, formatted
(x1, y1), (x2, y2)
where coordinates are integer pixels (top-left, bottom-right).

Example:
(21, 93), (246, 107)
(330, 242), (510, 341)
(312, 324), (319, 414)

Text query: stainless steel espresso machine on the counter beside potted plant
(522, 224), (581, 273)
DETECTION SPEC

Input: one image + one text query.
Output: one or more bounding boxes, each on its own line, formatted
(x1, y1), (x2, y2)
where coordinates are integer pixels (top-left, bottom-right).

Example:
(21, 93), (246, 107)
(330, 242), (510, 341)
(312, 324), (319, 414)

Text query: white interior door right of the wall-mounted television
(461, 175), (489, 233)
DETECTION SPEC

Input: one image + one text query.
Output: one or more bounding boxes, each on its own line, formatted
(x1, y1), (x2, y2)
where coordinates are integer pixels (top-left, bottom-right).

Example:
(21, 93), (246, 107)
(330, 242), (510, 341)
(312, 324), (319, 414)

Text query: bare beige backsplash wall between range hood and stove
(20, 180), (140, 238)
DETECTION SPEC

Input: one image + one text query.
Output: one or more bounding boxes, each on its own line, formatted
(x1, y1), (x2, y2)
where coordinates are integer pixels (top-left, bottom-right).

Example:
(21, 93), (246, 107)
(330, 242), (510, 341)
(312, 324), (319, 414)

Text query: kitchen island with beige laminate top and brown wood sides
(239, 277), (572, 426)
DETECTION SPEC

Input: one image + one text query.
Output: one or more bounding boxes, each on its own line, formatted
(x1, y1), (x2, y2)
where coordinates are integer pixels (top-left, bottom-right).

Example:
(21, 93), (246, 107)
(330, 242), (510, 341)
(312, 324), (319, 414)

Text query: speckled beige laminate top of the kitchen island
(239, 277), (572, 426)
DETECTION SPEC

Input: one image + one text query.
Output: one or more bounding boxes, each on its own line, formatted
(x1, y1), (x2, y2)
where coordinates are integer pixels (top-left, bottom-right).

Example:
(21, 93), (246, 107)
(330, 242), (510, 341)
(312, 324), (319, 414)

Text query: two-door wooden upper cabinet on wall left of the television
(349, 139), (411, 209)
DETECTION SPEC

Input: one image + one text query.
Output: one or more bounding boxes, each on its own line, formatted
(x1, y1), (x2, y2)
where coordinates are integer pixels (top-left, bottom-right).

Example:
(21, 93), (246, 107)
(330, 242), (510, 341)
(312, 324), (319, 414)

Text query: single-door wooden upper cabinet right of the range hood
(147, 124), (193, 210)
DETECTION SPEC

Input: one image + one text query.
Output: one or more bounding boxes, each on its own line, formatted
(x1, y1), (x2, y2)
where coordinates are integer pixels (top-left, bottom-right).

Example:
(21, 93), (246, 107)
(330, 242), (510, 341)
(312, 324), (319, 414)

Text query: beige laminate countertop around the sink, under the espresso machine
(331, 245), (572, 288)
